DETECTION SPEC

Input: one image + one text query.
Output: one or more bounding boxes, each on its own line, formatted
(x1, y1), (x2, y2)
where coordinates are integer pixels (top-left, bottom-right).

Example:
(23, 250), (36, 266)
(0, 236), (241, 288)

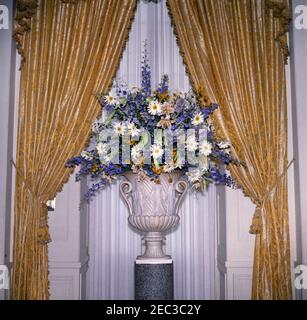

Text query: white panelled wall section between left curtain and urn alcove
(49, 175), (89, 300)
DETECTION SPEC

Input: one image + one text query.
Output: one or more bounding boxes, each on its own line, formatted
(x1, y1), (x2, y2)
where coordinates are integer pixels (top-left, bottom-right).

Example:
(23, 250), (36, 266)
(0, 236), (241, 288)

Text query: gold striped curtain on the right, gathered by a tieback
(168, 0), (291, 299)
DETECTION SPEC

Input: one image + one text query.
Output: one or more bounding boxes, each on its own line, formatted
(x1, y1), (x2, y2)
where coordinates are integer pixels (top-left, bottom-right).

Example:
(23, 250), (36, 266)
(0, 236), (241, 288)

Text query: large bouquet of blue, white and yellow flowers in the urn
(67, 45), (237, 199)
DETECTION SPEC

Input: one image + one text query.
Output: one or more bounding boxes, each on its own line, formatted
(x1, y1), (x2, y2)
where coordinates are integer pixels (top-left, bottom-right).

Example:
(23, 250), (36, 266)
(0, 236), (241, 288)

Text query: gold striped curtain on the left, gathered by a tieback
(13, 0), (136, 299)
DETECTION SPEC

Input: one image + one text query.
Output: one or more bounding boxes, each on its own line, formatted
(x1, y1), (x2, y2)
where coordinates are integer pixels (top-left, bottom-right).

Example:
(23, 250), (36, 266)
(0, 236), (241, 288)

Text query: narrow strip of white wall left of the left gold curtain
(0, 0), (16, 300)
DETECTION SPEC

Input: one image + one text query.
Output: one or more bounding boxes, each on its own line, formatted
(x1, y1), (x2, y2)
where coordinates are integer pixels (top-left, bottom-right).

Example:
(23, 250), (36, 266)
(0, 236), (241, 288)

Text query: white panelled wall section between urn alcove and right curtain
(217, 187), (255, 300)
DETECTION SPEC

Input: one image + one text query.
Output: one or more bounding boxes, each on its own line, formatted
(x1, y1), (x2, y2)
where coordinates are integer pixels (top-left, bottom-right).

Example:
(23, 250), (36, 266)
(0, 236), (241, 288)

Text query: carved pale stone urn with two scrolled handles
(120, 171), (188, 260)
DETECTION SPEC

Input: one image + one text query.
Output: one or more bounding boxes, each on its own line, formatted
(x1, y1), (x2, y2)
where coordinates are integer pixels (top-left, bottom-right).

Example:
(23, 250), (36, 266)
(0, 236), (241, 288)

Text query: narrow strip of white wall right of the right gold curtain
(290, 0), (307, 300)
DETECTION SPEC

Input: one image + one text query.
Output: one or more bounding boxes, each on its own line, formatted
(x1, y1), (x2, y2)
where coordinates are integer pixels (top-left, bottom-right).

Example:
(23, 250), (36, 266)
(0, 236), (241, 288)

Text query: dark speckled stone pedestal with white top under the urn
(135, 259), (174, 300)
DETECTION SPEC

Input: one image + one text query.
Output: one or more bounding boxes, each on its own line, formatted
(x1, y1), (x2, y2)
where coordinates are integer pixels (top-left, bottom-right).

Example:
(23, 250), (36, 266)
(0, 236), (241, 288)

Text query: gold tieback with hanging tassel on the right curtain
(249, 159), (295, 234)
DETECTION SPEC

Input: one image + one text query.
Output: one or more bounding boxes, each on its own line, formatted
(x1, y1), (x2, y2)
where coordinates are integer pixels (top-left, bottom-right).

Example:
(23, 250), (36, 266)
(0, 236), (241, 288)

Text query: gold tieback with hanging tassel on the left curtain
(11, 160), (51, 244)
